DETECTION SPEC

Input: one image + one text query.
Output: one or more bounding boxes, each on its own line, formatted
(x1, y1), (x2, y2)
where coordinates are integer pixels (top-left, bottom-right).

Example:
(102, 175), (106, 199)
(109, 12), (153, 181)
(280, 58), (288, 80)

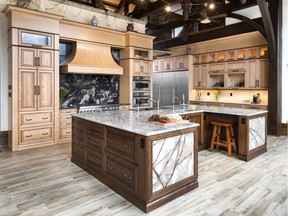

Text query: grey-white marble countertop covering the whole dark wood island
(73, 105), (267, 136)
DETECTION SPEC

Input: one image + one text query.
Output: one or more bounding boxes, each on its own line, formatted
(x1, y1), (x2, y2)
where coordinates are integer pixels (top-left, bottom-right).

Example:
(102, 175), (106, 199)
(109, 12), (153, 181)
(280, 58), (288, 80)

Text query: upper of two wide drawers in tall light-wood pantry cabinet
(20, 112), (53, 126)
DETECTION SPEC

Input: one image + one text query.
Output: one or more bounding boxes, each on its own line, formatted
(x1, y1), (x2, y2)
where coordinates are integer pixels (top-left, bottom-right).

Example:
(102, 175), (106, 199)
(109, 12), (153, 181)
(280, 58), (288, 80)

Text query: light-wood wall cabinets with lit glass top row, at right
(193, 46), (268, 89)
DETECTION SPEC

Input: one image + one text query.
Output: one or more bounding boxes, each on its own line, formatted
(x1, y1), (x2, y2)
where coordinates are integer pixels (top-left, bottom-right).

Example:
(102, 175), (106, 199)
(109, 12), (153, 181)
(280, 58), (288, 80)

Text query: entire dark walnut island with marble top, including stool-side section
(72, 105), (267, 212)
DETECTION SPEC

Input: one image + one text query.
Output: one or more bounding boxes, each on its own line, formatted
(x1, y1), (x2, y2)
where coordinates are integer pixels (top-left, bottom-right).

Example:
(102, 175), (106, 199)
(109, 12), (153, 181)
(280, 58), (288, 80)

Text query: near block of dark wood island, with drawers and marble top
(72, 110), (199, 212)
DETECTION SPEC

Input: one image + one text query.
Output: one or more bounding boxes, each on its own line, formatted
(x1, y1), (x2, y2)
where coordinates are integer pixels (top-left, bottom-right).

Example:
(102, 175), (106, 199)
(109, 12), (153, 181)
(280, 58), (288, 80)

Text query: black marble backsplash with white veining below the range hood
(59, 73), (119, 108)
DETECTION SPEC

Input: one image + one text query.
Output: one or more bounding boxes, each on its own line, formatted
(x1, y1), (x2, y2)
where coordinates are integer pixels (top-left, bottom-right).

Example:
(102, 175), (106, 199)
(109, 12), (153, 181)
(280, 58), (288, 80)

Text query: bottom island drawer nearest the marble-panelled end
(106, 154), (138, 194)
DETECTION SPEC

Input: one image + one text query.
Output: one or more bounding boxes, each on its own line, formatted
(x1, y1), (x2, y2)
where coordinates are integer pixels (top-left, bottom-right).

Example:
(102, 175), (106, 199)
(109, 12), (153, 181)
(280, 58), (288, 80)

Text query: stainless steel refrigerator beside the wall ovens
(152, 71), (189, 106)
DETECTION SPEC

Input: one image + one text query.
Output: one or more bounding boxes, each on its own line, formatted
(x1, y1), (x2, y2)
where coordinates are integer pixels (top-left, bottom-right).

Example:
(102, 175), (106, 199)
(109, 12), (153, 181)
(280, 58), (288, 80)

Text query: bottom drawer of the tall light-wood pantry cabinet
(20, 127), (53, 144)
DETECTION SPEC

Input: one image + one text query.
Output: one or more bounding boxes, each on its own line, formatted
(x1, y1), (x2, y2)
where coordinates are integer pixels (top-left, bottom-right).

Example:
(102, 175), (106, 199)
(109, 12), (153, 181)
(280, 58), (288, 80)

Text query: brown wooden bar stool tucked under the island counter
(210, 121), (237, 156)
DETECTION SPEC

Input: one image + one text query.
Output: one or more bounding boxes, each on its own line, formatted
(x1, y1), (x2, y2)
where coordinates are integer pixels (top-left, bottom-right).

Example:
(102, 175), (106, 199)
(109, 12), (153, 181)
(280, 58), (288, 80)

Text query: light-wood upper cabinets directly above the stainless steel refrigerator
(153, 55), (189, 72)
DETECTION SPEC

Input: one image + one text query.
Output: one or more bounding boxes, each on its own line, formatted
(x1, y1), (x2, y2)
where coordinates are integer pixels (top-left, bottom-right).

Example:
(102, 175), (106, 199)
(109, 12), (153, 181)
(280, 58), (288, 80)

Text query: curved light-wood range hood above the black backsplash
(60, 41), (123, 75)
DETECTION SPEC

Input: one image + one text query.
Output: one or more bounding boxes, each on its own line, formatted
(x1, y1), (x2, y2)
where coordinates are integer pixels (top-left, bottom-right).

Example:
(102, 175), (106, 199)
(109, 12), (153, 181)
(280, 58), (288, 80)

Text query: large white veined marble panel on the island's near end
(152, 132), (194, 193)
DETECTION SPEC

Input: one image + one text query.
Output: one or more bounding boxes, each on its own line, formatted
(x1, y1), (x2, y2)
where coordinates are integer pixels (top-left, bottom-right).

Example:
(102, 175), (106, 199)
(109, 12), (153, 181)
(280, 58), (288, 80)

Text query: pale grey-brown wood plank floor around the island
(0, 136), (288, 216)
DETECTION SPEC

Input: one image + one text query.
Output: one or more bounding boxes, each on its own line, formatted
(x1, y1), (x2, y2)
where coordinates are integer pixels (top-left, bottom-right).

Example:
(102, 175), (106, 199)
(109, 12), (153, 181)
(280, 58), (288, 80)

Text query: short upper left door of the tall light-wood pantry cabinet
(19, 47), (37, 69)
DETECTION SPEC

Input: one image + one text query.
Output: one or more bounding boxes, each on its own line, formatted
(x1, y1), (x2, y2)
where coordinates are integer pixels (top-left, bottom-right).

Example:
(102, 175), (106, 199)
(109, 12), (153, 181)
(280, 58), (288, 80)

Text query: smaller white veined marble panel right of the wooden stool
(249, 117), (266, 150)
